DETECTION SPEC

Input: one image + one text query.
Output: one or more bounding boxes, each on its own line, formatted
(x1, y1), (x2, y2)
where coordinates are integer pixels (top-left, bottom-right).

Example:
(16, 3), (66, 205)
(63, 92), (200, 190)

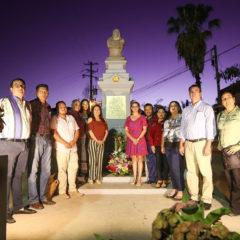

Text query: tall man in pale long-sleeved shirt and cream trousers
(179, 85), (216, 210)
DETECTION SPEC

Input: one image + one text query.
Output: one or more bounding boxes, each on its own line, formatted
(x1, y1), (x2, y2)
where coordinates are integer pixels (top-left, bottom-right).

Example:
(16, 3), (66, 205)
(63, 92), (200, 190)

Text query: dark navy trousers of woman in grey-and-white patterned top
(165, 147), (184, 191)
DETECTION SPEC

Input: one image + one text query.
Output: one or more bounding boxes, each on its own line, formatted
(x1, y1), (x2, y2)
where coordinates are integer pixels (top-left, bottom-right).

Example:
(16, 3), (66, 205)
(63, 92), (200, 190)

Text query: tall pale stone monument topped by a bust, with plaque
(98, 29), (134, 132)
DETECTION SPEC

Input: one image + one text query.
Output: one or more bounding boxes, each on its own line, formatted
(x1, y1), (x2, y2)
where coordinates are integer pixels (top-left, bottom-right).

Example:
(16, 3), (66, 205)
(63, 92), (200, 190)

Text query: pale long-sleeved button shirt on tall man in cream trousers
(181, 101), (216, 141)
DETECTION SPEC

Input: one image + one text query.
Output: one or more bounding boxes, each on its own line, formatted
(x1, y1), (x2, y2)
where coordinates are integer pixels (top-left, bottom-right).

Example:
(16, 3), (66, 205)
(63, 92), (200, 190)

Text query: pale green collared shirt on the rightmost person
(217, 106), (240, 149)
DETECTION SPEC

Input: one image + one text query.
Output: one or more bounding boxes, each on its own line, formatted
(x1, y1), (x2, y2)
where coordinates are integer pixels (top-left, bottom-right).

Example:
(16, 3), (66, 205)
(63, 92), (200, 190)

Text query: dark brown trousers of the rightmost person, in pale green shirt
(225, 168), (240, 214)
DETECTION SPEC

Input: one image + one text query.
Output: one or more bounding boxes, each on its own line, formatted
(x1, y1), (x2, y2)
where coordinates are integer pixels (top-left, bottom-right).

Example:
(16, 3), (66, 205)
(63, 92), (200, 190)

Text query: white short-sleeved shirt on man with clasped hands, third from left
(51, 115), (79, 152)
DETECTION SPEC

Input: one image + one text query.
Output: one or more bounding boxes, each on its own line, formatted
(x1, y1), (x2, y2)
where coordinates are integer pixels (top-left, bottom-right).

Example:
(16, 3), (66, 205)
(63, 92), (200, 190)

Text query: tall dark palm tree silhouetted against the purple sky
(167, 4), (220, 86)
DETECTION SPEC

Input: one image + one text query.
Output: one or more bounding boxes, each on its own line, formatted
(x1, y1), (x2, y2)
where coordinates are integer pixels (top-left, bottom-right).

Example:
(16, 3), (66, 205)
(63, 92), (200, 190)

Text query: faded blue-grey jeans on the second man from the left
(28, 136), (52, 204)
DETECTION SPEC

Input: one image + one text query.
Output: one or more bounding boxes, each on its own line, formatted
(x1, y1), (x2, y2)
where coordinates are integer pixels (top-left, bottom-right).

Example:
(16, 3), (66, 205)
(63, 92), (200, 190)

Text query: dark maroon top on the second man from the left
(30, 98), (51, 135)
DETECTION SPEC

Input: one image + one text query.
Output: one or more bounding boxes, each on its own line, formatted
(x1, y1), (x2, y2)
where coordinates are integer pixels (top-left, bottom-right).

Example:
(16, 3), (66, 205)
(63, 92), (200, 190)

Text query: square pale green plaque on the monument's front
(106, 96), (126, 119)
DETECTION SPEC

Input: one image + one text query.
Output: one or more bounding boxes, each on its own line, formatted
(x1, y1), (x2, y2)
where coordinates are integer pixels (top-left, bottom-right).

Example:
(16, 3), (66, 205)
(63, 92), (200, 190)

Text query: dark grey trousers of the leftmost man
(0, 140), (29, 212)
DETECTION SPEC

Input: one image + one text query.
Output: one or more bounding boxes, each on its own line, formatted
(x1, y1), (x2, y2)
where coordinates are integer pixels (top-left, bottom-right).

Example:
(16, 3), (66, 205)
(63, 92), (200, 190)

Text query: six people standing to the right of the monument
(124, 85), (240, 216)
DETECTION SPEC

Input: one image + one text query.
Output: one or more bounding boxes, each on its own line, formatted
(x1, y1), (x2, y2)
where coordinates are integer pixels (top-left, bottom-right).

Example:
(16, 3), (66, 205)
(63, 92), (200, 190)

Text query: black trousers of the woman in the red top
(155, 146), (168, 181)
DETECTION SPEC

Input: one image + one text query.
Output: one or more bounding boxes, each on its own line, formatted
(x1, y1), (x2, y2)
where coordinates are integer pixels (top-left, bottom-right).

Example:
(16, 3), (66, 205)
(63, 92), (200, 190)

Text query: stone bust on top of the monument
(106, 29), (125, 60)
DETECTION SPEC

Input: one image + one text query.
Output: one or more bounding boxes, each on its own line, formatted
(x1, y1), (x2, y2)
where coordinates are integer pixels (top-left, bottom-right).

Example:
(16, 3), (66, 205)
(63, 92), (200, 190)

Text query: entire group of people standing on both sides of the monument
(0, 78), (240, 223)
